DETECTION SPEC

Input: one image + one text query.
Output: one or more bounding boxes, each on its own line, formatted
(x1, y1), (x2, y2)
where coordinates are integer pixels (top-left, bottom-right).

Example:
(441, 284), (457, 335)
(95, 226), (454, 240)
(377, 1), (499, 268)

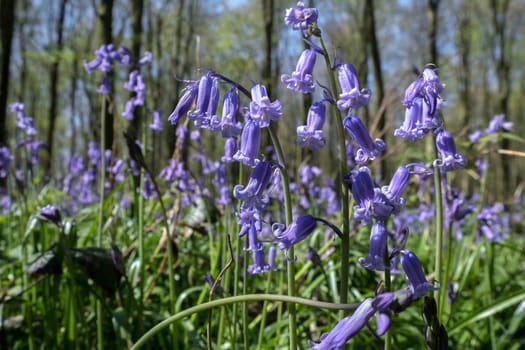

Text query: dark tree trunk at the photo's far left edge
(0, 0), (16, 145)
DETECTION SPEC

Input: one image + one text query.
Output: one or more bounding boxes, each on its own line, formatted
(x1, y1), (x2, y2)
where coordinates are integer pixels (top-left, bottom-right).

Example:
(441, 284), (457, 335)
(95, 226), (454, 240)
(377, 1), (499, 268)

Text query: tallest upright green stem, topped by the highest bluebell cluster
(319, 32), (350, 303)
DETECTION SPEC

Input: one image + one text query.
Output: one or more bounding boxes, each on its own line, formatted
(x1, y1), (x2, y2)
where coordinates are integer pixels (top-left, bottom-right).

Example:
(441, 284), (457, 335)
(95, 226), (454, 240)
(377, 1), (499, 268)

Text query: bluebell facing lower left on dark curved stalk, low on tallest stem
(272, 214), (317, 250)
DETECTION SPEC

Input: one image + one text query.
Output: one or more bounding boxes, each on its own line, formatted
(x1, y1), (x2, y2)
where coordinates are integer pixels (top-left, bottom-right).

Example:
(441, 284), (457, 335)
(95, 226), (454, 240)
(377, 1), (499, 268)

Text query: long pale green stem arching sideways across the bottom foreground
(130, 294), (359, 350)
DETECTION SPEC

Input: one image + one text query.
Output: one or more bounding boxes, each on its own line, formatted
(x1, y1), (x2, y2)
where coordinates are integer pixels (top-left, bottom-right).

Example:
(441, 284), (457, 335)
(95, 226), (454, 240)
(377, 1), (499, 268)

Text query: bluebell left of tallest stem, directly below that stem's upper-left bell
(297, 102), (327, 151)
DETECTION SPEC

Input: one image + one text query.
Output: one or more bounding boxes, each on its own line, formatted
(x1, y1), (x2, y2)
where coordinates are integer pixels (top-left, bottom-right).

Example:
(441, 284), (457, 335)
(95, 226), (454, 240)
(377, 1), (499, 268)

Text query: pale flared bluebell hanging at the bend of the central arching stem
(250, 84), (283, 128)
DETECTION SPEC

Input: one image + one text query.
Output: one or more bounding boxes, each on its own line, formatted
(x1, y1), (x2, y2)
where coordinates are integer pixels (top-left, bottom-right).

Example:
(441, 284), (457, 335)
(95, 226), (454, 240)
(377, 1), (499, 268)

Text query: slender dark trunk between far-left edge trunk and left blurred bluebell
(44, 0), (67, 175)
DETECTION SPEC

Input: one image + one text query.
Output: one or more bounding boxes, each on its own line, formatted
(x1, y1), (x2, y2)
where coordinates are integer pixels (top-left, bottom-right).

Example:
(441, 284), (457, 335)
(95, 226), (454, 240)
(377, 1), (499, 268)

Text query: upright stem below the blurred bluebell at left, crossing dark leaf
(96, 96), (107, 350)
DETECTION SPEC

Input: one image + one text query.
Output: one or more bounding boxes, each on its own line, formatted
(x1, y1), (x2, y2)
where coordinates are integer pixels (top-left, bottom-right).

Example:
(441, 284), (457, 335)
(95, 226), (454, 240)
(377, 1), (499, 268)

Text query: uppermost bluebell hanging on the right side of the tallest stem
(337, 63), (370, 111)
